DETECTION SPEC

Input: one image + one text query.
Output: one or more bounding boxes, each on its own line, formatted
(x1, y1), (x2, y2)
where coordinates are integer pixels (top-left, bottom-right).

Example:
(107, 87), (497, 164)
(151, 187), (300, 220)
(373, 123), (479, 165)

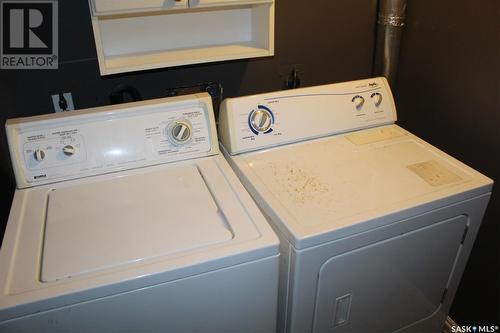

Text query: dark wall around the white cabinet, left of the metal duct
(0, 0), (377, 237)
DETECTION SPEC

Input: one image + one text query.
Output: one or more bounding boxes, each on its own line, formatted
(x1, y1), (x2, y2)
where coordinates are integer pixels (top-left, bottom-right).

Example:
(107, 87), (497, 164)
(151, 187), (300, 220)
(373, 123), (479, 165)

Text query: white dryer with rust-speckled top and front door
(219, 78), (492, 333)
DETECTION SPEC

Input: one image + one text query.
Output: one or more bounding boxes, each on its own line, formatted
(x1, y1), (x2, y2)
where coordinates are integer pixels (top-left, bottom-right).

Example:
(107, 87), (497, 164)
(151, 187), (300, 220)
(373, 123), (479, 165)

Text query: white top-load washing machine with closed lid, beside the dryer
(0, 93), (279, 333)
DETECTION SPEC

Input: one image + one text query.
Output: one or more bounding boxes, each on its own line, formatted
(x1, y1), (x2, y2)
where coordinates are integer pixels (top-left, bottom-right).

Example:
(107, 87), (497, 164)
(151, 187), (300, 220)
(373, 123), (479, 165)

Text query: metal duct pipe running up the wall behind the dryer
(373, 0), (407, 87)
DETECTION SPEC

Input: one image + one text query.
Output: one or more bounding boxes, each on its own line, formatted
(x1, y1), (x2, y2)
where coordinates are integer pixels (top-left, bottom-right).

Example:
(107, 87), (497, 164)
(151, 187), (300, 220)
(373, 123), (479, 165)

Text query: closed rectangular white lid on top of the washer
(41, 165), (233, 282)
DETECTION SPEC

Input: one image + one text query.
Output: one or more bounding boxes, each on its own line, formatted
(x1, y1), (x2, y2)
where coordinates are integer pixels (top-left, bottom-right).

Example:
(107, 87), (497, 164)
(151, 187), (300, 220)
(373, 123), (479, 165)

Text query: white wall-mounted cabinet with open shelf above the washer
(90, 0), (274, 75)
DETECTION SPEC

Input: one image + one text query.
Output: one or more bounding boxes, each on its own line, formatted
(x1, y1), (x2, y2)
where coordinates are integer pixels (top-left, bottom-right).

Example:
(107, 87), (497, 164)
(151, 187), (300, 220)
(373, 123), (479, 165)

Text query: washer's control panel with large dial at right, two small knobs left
(6, 93), (218, 188)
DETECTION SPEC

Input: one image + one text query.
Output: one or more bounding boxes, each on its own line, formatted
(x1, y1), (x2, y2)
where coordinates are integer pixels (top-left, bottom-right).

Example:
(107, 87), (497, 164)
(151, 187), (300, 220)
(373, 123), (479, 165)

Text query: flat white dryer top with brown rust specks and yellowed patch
(233, 125), (492, 249)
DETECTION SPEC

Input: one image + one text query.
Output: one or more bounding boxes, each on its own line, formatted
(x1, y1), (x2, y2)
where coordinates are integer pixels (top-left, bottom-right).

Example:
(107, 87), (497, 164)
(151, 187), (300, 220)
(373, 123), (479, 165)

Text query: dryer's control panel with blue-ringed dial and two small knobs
(219, 78), (396, 154)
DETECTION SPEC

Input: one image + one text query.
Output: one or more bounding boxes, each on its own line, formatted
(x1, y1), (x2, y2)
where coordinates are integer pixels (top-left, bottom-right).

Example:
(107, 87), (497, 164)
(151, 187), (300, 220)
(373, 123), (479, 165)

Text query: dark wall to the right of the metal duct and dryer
(395, 0), (500, 325)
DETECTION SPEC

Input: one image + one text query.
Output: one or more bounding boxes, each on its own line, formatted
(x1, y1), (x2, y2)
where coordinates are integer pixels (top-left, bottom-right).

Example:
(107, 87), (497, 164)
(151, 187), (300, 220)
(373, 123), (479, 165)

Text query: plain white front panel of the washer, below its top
(0, 256), (279, 333)
